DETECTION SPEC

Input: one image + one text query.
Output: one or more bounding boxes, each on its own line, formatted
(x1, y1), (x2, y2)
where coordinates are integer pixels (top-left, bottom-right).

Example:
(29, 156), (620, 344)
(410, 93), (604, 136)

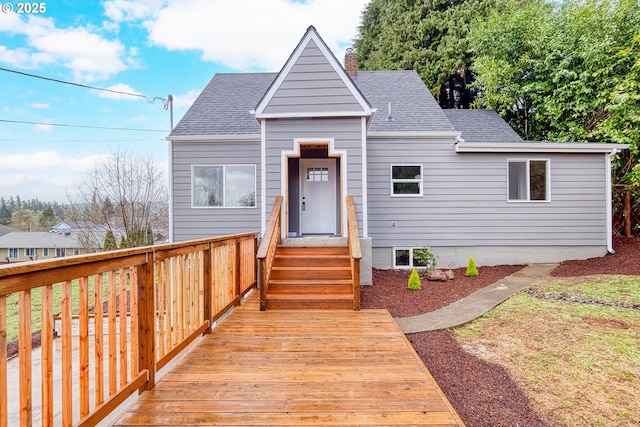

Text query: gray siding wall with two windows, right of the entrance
(368, 139), (607, 264)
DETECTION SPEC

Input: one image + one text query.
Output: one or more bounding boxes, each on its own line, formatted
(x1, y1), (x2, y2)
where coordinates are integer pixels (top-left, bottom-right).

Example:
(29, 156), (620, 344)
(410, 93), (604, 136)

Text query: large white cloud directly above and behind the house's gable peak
(105, 0), (368, 71)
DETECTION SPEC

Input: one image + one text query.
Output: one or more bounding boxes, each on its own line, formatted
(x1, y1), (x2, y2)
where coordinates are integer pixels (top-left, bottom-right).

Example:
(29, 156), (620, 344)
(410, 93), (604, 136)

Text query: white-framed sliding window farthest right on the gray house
(507, 159), (551, 202)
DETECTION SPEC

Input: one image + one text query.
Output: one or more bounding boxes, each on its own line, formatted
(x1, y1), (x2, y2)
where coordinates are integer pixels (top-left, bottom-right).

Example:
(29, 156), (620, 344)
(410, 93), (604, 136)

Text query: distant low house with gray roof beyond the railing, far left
(0, 231), (86, 262)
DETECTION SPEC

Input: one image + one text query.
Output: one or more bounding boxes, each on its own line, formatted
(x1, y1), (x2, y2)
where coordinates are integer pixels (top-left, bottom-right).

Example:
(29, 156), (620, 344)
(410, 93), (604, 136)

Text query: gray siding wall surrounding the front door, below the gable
(265, 118), (362, 236)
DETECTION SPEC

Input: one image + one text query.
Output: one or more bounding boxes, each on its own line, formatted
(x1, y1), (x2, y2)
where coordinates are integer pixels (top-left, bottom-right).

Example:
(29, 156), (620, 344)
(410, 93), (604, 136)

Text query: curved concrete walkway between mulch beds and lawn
(395, 264), (558, 334)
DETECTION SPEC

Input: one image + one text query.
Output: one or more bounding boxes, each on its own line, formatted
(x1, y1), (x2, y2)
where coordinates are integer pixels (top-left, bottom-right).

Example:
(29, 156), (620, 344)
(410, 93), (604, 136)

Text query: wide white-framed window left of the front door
(191, 165), (256, 208)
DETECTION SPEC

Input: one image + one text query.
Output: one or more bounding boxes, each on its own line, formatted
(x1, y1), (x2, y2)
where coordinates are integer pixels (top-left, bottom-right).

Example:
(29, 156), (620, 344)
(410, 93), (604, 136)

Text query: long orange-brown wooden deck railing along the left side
(0, 233), (257, 427)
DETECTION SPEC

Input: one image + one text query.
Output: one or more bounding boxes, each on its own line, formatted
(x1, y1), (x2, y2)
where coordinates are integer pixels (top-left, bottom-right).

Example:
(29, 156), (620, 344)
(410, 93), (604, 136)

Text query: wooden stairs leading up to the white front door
(267, 244), (354, 310)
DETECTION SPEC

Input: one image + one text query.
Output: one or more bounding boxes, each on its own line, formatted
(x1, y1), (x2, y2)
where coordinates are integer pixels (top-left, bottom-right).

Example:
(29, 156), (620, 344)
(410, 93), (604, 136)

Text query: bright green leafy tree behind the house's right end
(469, 0), (640, 234)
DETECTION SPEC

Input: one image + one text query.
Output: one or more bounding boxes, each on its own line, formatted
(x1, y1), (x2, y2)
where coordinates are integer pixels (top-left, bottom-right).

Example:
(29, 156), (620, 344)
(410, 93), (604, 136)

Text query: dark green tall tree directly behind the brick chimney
(355, 0), (504, 108)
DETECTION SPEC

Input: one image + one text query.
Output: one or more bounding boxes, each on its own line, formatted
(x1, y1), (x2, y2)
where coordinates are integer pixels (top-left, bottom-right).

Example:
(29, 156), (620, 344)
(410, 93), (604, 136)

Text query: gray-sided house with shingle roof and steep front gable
(168, 27), (626, 283)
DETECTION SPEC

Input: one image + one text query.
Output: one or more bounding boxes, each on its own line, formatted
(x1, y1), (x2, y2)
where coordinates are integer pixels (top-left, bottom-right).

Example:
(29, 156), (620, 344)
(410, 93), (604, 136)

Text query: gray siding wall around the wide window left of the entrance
(171, 141), (262, 241)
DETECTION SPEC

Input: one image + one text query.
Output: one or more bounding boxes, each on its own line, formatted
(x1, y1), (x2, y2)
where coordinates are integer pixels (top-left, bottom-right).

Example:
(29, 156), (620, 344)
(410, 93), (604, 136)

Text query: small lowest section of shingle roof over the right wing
(443, 110), (522, 142)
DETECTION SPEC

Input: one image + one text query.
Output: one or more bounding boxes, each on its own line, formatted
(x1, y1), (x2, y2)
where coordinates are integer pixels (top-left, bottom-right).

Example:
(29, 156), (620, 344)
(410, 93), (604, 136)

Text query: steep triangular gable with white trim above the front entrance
(254, 26), (374, 120)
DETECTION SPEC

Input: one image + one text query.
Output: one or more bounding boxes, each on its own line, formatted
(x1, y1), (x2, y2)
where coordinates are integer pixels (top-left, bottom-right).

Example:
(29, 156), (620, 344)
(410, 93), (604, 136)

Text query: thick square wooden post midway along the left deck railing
(136, 254), (156, 391)
